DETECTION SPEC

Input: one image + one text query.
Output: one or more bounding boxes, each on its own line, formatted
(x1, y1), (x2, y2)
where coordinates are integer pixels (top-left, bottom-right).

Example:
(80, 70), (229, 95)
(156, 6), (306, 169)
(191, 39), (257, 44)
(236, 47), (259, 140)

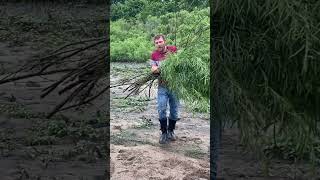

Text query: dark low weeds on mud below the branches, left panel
(0, 104), (107, 146)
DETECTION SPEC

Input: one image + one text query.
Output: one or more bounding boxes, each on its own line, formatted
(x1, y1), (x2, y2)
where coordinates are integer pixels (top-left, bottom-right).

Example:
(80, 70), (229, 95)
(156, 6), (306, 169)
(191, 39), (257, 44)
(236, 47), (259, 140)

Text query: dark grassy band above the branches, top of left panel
(0, 3), (105, 49)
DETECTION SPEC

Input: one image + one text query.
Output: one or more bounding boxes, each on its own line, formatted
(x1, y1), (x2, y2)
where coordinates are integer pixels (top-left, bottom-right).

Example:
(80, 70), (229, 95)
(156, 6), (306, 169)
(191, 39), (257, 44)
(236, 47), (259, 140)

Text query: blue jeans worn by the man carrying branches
(158, 85), (180, 121)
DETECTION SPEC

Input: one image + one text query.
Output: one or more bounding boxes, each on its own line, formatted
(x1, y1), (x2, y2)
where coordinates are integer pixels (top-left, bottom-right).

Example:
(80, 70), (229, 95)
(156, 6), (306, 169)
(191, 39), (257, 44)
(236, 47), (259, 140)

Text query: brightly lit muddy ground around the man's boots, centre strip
(110, 63), (210, 180)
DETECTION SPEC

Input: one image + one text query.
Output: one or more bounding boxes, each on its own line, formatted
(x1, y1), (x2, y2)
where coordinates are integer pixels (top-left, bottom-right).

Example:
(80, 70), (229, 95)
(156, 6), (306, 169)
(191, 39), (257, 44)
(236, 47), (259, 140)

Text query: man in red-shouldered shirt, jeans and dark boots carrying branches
(151, 35), (179, 144)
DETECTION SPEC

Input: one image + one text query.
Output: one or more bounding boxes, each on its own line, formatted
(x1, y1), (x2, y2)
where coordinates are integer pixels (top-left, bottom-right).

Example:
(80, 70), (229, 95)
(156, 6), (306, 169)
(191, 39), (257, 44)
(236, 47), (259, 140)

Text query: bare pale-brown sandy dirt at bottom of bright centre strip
(111, 145), (209, 180)
